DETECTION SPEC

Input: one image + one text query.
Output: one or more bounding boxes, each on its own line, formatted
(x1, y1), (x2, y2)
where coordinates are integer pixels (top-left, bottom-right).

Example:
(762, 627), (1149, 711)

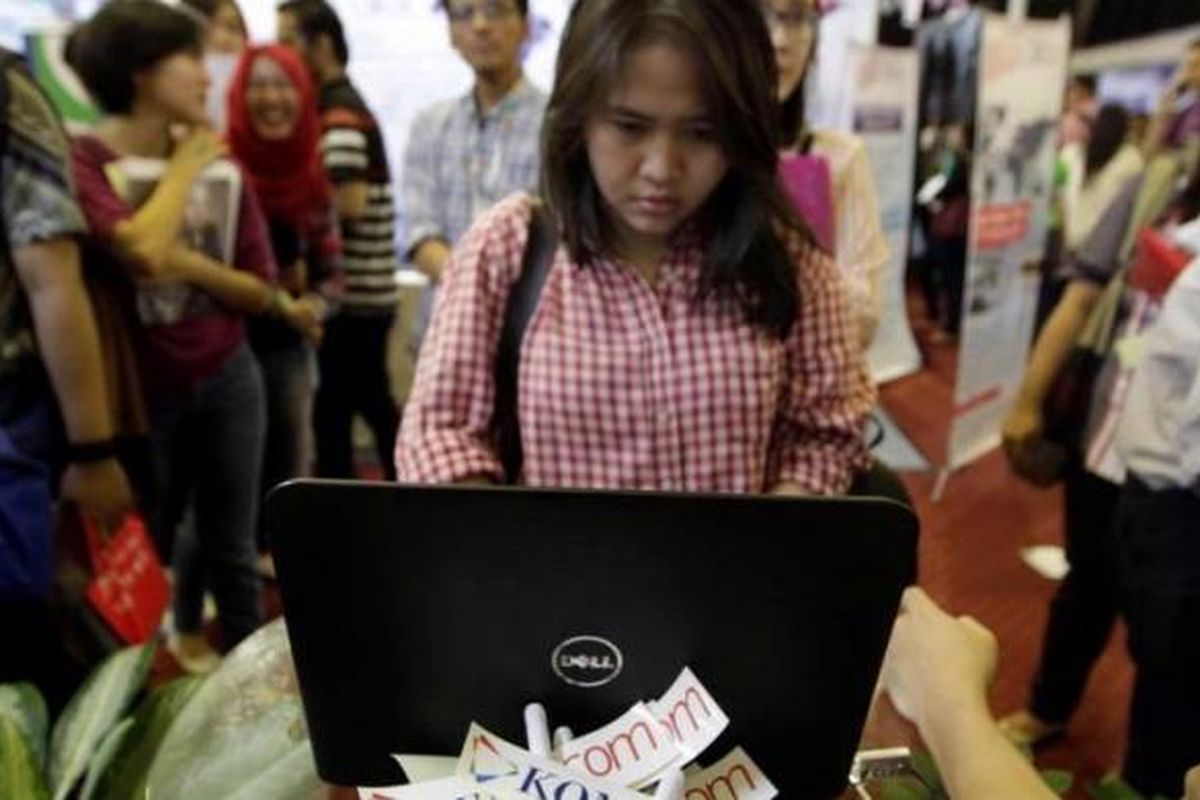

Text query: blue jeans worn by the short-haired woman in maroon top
(150, 343), (266, 648)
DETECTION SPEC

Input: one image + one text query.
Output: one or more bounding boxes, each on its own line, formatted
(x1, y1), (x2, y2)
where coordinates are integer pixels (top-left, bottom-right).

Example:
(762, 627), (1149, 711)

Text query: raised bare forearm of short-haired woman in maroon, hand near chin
(113, 162), (198, 275)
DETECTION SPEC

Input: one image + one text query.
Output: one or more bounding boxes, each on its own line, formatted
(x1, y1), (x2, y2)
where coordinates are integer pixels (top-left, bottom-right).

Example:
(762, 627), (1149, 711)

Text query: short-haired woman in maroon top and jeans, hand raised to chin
(68, 0), (319, 667)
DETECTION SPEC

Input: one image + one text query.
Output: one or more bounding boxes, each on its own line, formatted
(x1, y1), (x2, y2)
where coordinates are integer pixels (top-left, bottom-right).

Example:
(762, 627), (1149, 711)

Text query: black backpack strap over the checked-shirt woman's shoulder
(492, 203), (558, 483)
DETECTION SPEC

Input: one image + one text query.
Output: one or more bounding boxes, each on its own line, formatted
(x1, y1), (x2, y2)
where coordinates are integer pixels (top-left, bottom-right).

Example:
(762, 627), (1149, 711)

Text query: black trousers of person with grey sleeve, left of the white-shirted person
(1030, 465), (1121, 724)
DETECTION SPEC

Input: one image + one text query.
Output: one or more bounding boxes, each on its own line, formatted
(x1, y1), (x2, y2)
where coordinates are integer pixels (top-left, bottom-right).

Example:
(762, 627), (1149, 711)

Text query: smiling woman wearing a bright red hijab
(229, 44), (341, 568)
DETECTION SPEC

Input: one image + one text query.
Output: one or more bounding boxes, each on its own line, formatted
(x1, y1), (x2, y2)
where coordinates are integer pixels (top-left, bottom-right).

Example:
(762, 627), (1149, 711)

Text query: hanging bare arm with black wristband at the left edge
(12, 239), (133, 519)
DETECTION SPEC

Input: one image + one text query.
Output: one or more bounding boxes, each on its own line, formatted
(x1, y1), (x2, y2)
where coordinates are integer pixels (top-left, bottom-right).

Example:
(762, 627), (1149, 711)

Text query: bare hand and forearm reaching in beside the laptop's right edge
(880, 588), (1055, 800)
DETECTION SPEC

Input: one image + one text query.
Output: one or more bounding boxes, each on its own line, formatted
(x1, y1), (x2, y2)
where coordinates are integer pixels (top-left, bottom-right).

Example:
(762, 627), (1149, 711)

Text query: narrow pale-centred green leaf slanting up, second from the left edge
(49, 643), (154, 800)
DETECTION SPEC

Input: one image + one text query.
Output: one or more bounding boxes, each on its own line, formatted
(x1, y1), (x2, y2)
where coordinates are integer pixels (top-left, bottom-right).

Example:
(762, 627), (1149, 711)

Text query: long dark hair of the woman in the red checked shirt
(541, 0), (812, 337)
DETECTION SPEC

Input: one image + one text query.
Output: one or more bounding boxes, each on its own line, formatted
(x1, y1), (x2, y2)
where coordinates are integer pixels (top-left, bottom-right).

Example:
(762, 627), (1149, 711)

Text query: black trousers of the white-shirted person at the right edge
(1116, 476), (1200, 798)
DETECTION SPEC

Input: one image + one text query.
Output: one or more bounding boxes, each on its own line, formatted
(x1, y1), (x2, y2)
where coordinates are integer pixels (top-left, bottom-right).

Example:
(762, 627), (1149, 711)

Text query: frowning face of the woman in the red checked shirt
(584, 42), (728, 260)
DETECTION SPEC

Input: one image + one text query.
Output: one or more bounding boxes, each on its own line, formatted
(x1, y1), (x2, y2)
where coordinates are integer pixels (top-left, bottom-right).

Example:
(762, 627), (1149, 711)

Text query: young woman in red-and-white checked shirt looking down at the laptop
(396, 0), (874, 494)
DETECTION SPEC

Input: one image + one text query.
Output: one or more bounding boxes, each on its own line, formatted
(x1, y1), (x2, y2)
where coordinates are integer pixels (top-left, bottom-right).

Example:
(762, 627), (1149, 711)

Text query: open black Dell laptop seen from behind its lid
(268, 481), (918, 798)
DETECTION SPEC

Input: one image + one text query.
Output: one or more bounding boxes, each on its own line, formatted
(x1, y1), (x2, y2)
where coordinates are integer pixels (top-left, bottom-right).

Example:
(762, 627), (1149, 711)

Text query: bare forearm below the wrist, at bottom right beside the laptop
(920, 698), (1055, 800)
